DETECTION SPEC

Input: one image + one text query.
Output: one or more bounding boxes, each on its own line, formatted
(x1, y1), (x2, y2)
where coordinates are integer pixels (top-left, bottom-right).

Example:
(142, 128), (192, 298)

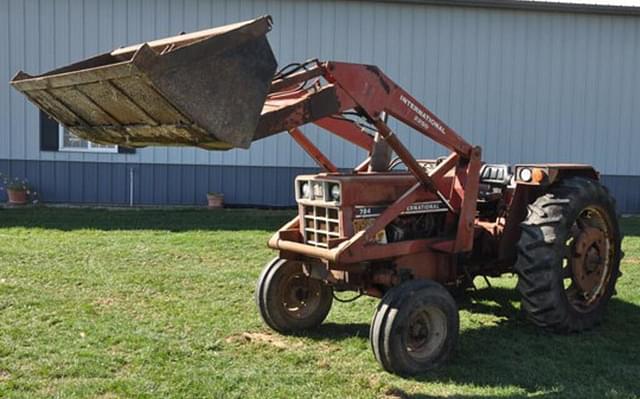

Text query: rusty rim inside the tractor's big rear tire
(562, 206), (615, 313)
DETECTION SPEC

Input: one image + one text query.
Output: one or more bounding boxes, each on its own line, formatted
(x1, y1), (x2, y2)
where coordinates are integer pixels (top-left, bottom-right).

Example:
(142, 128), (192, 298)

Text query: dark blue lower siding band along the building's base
(0, 159), (640, 213)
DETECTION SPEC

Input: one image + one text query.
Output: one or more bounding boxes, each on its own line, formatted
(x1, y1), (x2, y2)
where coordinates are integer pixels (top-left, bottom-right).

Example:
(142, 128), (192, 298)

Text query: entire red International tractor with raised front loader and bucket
(12, 17), (622, 375)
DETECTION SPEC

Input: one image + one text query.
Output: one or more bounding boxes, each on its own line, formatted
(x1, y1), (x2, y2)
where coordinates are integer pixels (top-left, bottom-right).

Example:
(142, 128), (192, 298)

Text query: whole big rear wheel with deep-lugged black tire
(515, 177), (621, 333)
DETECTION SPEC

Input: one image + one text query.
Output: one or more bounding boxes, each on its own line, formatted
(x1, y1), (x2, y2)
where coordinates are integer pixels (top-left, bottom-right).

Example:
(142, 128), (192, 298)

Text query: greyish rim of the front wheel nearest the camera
(404, 306), (447, 362)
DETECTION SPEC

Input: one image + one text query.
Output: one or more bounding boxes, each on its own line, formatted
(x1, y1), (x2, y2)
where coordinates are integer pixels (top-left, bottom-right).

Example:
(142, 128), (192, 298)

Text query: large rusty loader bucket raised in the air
(11, 16), (277, 150)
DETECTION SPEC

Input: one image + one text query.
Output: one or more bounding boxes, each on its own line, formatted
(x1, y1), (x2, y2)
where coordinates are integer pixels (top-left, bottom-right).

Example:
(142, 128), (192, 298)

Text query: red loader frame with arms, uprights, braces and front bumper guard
(256, 61), (481, 295)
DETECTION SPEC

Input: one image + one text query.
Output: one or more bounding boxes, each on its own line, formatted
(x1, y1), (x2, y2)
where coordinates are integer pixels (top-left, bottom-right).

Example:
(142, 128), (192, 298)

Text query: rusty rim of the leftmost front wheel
(279, 270), (322, 319)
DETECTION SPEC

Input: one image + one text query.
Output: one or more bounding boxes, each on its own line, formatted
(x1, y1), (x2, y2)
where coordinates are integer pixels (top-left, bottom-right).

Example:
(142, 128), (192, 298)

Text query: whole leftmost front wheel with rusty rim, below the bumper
(255, 258), (333, 334)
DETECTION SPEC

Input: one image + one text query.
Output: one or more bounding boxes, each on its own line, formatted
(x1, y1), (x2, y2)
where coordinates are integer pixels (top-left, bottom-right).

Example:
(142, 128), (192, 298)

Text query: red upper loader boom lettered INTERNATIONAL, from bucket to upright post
(254, 61), (473, 158)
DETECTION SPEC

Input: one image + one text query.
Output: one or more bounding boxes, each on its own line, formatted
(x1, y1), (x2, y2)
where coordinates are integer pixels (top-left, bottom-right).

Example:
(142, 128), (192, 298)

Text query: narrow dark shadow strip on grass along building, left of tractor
(0, 207), (295, 232)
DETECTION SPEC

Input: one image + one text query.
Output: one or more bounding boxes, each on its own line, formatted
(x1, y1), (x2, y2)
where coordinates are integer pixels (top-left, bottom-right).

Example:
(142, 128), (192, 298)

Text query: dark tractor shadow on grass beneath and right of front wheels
(306, 288), (640, 398)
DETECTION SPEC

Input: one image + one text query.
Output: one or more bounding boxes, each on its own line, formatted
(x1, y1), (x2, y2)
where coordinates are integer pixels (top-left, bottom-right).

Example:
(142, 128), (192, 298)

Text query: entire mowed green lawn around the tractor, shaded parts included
(0, 208), (640, 398)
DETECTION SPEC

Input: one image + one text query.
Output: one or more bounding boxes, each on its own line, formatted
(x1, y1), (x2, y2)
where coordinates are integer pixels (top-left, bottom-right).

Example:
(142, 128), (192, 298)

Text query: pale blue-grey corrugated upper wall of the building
(0, 0), (640, 175)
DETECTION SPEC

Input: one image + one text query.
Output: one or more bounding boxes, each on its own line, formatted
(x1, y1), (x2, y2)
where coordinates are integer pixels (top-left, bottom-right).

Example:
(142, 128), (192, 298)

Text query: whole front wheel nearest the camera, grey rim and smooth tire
(369, 280), (460, 375)
